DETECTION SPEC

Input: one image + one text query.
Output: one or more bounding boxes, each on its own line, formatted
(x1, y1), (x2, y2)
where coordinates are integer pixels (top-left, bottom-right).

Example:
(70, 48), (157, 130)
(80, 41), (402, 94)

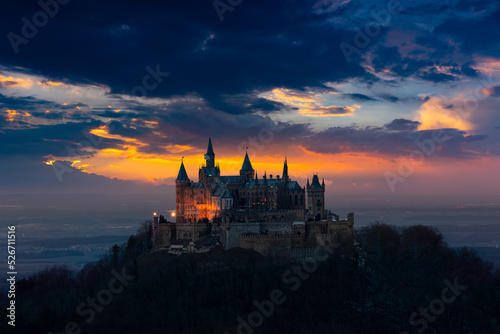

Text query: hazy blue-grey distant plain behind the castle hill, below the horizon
(0, 194), (500, 286)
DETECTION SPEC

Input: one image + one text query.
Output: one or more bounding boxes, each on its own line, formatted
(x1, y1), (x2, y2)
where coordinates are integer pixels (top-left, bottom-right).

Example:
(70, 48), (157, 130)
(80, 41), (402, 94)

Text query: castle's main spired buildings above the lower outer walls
(175, 138), (326, 223)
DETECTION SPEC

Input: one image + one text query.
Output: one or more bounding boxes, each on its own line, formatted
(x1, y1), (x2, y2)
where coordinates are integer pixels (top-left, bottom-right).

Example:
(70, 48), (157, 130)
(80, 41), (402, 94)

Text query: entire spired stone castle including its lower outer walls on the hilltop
(153, 138), (354, 256)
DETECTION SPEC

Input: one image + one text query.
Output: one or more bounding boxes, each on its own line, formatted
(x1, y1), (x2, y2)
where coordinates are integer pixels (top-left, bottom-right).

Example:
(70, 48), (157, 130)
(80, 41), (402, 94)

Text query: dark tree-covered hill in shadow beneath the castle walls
(2, 223), (500, 334)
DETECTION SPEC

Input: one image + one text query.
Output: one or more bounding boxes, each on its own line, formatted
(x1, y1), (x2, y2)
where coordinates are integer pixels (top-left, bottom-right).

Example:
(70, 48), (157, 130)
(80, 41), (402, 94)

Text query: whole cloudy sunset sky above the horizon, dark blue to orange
(0, 0), (500, 198)
